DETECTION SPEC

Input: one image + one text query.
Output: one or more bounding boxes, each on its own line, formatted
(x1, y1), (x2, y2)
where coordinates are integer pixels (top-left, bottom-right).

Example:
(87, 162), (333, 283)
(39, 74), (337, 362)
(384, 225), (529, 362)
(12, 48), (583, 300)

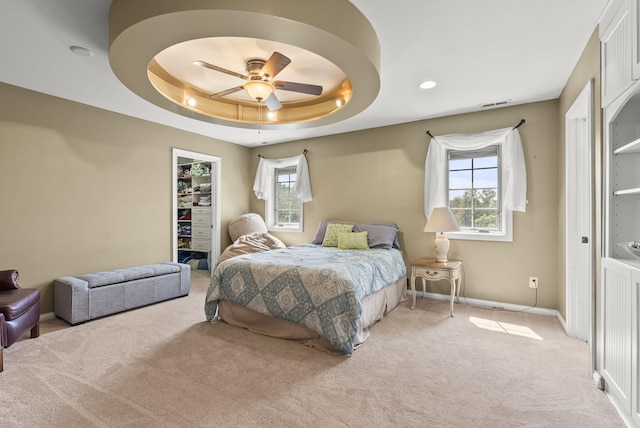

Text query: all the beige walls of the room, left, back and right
(0, 30), (602, 315)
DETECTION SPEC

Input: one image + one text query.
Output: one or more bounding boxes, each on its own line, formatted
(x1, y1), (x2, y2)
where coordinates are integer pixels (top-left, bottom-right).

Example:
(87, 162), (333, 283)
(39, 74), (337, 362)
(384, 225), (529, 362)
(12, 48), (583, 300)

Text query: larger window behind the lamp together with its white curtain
(424, 127), (527, 242)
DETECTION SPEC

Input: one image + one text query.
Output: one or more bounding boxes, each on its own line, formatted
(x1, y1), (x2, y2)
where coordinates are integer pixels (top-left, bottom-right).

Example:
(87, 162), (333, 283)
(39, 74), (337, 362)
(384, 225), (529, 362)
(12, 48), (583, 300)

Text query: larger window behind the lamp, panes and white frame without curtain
(447, 144), (512, 241)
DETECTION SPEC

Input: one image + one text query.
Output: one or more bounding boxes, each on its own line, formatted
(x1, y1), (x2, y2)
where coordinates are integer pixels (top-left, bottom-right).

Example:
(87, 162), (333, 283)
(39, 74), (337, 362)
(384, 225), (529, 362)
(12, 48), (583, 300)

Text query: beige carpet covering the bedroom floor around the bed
(0, 271), (624, 427)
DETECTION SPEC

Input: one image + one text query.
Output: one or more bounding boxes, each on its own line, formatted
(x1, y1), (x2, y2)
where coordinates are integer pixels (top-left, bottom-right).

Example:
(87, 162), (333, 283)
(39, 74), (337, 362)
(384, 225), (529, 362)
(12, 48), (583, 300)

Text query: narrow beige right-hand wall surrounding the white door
(557, 28), (602, 319)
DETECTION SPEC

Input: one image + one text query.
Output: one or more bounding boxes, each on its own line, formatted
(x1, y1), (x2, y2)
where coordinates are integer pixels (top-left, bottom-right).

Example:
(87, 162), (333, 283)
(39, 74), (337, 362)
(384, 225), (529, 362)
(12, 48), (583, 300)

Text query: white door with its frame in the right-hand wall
(565, 80), (595, 348)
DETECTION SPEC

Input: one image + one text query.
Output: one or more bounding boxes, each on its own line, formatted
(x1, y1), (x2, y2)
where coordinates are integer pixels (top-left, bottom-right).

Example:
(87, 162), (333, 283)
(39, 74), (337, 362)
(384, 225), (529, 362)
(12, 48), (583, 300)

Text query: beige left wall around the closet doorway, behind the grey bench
(0, 84), (253, 312)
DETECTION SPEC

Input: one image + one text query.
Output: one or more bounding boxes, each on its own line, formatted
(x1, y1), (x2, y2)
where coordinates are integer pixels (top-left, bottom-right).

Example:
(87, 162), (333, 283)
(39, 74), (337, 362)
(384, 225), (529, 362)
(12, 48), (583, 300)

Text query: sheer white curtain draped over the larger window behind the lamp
(424, 128), (527, 218)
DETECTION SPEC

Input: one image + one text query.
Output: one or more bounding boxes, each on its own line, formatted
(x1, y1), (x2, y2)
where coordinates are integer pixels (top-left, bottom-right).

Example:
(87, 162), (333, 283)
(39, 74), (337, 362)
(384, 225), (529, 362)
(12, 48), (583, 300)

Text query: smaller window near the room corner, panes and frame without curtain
(266, 167), (302, 231)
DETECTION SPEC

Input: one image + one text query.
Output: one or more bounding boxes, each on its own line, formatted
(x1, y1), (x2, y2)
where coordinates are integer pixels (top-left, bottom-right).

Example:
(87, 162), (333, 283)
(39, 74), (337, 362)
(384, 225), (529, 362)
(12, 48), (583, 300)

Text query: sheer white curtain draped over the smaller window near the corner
(253, 155), (313, 203)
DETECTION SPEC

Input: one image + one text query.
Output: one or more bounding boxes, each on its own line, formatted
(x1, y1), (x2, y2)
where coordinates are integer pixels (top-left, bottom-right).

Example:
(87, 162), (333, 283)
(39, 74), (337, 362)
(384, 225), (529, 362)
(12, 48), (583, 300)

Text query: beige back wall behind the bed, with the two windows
(251, 100), (560, 309)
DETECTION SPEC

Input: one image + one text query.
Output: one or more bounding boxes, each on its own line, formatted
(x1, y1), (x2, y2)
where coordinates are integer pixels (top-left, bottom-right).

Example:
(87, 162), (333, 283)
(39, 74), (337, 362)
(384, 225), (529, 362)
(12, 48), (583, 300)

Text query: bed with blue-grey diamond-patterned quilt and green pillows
(205, 222), (406, 355)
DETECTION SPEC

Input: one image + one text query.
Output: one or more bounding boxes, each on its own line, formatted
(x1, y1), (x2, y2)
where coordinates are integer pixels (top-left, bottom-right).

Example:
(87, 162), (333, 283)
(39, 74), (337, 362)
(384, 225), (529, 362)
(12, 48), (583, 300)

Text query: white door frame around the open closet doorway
(171, 147), (222, 273)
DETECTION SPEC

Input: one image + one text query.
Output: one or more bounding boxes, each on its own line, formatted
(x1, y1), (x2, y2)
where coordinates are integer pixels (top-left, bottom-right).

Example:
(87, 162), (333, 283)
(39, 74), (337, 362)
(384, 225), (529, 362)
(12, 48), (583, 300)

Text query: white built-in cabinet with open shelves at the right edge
(596, 0), (640, 427)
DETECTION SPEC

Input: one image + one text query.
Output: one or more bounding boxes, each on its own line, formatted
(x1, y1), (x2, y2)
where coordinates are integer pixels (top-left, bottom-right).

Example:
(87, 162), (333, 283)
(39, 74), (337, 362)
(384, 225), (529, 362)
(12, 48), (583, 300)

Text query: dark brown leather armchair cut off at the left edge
(0, 270), (40, 371)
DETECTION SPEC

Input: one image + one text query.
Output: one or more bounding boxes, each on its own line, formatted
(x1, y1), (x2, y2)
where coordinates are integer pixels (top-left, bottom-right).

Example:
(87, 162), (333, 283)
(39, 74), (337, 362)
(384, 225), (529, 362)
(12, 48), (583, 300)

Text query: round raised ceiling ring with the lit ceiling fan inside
(109, 0), (380, 129)
